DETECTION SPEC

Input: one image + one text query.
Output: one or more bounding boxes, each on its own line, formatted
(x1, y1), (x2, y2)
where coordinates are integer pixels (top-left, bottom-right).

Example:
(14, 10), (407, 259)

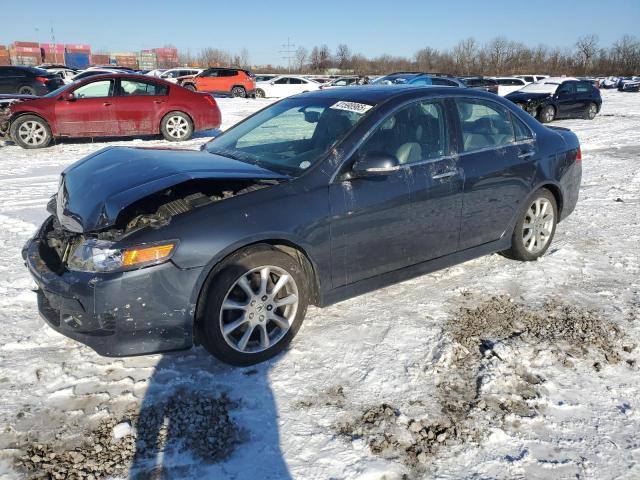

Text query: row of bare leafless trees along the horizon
(181, 34), (640, 76)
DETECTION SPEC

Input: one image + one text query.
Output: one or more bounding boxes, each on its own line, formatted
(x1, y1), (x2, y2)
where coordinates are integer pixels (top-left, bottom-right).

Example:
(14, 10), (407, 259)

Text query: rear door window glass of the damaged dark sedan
(456, 99), (515, 152)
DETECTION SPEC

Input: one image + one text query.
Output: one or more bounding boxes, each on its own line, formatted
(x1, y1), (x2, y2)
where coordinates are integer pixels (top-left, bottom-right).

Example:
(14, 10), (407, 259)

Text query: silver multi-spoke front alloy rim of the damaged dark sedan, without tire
(220, 265), (299, 353)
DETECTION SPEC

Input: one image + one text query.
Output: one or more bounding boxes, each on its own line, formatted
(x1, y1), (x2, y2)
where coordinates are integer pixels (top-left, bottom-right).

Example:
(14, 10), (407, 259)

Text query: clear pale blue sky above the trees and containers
(0, 0), (640, 65)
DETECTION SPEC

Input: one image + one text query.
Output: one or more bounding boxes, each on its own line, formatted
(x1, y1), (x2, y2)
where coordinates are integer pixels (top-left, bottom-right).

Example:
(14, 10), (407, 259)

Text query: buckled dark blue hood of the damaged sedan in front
(56, 147), (287, 233)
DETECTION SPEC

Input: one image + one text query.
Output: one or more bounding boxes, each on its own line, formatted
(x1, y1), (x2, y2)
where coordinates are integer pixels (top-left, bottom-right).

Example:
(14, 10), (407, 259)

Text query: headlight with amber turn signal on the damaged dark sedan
(67, 239), (177, 273)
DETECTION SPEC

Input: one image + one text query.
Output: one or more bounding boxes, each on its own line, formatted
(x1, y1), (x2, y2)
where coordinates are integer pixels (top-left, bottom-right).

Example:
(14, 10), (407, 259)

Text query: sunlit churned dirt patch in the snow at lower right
(336, 296), (631, 475)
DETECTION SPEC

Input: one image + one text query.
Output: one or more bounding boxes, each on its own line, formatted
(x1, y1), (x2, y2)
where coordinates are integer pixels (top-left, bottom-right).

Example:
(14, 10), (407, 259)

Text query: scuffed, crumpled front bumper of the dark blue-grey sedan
(22, 218), (201, 357)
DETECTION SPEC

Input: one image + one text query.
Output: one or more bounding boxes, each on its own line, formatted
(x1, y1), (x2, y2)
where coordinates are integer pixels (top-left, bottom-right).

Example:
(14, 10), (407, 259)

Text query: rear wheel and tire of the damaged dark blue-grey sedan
(502, 188), (558, 262)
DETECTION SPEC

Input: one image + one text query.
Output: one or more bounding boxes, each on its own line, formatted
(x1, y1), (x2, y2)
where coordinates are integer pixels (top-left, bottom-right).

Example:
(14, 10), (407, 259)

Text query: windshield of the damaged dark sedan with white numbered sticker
(205, 97), (373, 176)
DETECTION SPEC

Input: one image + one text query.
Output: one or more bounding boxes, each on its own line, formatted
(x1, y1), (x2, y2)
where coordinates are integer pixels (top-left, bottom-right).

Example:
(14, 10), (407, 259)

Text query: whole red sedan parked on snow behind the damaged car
(0, 74), (221, 148)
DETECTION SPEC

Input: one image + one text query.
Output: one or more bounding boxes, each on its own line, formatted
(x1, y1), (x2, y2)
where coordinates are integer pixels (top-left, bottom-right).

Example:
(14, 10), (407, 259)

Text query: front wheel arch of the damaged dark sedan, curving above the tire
(192, 238), (321, 324)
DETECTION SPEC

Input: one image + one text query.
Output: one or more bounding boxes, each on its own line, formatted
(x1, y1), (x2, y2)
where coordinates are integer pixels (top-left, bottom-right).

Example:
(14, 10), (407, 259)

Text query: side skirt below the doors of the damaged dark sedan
(319, 235), (511, 307)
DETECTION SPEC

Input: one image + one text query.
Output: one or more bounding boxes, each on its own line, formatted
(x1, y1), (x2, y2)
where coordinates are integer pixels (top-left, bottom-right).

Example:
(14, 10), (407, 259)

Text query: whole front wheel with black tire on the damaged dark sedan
(199, 245), (309, 366)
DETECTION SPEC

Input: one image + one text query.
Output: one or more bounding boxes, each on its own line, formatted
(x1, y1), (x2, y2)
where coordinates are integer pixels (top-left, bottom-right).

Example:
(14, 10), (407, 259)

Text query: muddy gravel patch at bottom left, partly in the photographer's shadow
(15, 390), (241, 479)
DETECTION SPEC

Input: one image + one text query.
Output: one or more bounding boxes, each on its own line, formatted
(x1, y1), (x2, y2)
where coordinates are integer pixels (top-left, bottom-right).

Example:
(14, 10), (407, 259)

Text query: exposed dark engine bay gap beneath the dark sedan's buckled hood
(41, 179), (280, 271)
